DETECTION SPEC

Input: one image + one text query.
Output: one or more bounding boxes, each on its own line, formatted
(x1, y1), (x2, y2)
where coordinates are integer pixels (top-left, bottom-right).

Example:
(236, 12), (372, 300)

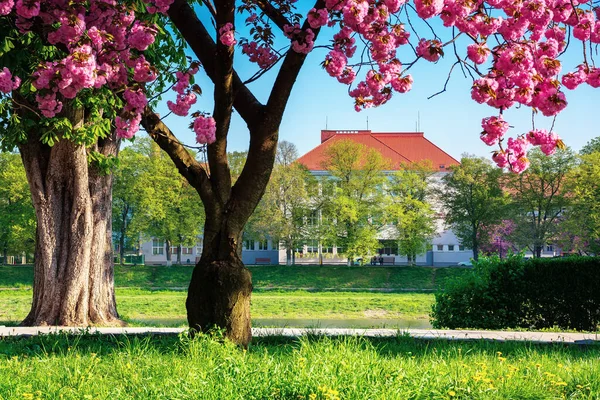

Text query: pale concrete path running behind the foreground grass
(0, 326), (600, 344)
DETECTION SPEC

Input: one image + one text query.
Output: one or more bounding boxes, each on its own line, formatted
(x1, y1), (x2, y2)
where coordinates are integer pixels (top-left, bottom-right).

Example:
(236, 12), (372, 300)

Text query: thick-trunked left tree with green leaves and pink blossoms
(0, 0), (190, 325)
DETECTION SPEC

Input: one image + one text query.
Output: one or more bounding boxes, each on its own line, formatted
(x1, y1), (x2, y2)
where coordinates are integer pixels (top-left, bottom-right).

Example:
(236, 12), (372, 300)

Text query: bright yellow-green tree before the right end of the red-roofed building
(388, 162), (435, 264)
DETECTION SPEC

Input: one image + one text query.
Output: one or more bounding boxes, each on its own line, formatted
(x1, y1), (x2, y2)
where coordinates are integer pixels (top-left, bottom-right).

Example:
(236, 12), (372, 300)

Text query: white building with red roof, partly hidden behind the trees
(141, 130), (473, 266)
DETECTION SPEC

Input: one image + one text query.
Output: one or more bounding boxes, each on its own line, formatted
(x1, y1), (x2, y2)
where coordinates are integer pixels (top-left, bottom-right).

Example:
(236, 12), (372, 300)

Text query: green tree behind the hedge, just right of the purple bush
(507, 149), (576, 257)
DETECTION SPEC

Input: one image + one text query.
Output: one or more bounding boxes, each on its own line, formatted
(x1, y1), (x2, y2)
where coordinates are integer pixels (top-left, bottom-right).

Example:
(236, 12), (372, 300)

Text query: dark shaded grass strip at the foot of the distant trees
(0, 266), (470, 290)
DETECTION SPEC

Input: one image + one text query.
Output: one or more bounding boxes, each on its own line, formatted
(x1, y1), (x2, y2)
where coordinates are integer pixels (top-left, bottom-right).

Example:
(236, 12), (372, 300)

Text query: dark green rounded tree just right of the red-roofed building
(442, 156), (506, 260)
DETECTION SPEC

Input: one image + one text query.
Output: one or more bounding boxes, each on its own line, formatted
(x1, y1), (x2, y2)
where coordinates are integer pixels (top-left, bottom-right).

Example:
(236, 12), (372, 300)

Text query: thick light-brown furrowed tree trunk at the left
(19, 123), (122, 326)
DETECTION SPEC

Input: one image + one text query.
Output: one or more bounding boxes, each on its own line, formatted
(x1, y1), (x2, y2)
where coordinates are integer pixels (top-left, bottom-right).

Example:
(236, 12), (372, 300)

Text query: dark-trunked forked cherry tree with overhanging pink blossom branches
(0, 0), (600, 344)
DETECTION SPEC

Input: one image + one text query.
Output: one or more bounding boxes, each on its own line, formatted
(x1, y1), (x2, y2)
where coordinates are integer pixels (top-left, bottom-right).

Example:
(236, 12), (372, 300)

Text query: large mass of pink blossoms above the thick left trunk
(0, 0), (172, 138)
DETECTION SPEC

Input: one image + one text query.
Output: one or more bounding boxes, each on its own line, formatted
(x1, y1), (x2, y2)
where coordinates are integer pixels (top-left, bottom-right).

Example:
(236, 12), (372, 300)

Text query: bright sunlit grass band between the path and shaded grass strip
(0, 289), (434, 326)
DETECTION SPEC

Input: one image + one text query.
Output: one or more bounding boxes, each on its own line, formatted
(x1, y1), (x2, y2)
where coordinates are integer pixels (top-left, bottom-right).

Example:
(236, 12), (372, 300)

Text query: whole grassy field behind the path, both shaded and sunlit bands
(0, 266), (468, 328)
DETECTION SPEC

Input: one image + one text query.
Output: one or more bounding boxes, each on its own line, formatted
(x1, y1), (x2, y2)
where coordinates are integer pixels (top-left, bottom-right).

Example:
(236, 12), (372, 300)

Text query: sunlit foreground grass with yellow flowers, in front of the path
(0, 336), (600, 400)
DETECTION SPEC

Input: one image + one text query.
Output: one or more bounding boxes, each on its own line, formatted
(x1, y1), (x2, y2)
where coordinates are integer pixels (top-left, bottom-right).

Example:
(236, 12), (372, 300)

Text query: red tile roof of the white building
(298, 130), (459, 171)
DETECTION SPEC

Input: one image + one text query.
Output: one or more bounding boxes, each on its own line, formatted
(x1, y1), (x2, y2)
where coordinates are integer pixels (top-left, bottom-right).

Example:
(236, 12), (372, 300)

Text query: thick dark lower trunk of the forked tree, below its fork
(185, 213), (252, 347)
